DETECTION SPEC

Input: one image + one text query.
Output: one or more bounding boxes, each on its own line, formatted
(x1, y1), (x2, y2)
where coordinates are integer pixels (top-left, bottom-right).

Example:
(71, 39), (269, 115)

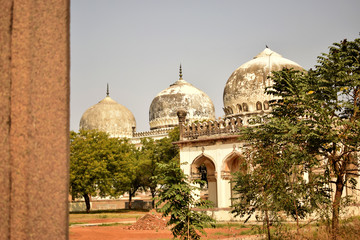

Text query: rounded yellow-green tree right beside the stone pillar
(70, 130), (136, 212)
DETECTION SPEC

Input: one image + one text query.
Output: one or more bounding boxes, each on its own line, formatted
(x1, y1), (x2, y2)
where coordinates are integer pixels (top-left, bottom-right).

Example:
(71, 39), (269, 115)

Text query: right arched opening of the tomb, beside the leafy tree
(221, 151), (247, 204)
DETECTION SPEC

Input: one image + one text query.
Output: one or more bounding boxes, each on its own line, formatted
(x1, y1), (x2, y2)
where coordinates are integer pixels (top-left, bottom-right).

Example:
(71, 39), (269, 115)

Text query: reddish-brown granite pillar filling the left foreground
(0, 0), (70, 240)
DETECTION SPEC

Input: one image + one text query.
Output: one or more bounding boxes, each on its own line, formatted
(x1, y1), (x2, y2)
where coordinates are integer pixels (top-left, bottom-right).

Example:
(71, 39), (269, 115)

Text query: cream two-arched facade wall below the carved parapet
(178, 139), (247, 210)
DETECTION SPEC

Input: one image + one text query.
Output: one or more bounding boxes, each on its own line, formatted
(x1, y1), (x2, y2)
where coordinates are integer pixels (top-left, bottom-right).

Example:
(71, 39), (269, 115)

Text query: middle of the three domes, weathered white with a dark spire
(149, 66), (215, 130)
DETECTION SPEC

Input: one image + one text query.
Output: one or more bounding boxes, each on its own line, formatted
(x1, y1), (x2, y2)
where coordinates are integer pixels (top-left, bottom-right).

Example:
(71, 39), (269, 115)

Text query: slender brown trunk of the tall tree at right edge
(331, 175), (344, 240)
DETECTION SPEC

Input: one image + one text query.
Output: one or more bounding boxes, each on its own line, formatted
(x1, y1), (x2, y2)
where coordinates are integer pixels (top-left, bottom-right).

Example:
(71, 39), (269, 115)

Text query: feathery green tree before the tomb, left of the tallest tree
(232, 94), (329, 239)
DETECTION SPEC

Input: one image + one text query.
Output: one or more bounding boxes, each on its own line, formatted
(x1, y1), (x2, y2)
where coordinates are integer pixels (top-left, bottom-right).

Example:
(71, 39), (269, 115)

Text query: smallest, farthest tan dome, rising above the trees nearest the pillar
(80, 89), (136, 138)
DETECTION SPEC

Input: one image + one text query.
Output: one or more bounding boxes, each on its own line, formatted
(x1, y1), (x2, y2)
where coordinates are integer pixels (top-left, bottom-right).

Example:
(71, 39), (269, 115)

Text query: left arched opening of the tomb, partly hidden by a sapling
(191, 154), (217, 207)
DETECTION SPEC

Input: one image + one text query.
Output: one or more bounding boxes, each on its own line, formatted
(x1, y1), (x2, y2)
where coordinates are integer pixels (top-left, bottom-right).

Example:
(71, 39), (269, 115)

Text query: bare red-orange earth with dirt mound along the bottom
(69, 214), (256, 240)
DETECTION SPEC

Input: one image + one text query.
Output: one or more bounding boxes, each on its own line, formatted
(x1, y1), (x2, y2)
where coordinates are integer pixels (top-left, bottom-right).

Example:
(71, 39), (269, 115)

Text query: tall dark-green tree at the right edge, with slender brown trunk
(307, 38), (360, 239)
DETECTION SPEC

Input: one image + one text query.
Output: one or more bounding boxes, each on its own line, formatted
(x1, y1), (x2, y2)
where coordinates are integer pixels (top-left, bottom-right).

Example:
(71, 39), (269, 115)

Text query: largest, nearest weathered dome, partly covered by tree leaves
(223, 48), (303, 116)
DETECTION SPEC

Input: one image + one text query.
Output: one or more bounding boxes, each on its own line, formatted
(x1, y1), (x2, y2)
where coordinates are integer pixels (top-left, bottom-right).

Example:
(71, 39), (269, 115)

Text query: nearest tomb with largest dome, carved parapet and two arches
(176, 48), (303, 220)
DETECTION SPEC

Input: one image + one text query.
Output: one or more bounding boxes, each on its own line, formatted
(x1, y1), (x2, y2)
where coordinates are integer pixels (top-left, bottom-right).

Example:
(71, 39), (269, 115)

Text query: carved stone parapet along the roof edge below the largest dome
(180, 117), (242, 139)
